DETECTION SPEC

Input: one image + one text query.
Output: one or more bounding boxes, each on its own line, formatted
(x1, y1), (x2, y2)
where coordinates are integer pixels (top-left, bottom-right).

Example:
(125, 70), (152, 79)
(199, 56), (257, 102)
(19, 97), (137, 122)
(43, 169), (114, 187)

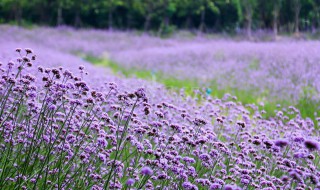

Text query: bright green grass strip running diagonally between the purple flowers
(85, 56), (320, 129)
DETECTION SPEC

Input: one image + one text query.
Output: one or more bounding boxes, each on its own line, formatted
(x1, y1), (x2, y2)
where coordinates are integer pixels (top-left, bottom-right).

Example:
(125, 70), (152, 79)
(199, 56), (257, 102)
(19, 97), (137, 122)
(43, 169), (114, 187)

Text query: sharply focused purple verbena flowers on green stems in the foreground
(0, 48), (320, 190)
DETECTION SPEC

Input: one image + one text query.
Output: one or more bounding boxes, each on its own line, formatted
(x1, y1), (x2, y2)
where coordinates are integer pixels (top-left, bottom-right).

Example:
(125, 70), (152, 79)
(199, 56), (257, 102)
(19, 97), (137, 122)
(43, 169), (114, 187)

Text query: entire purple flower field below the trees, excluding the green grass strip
(0, 26), (320, 190)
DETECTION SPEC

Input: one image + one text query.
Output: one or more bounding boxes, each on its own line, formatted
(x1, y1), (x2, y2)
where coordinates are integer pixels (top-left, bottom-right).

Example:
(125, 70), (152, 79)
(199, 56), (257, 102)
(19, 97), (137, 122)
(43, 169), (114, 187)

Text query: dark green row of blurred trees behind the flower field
(0, 0), (320, 38)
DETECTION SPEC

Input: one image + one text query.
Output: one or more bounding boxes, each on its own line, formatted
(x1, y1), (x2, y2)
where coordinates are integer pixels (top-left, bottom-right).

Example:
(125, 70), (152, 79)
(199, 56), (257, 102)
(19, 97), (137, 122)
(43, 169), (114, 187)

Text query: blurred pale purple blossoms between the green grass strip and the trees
(0, 26), (320, 101)
